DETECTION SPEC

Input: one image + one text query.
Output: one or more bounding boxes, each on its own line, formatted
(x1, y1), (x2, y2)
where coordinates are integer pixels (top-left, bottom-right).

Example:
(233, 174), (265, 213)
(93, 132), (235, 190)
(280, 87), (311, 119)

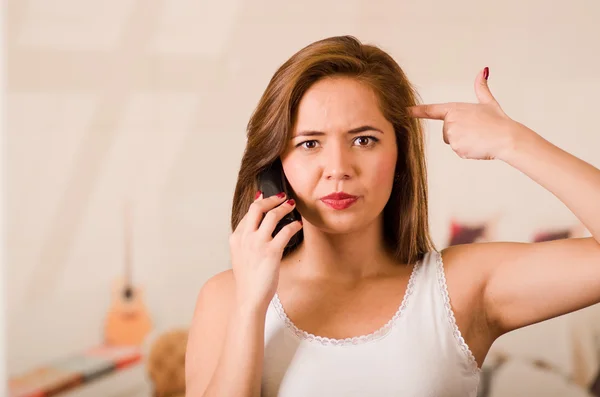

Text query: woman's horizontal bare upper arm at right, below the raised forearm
(448, 237), (600, 335)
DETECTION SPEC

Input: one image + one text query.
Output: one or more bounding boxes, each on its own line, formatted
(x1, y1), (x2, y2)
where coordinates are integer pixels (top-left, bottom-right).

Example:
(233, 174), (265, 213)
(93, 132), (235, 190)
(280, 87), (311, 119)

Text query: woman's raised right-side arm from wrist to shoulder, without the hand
(473, 123), (600, 332)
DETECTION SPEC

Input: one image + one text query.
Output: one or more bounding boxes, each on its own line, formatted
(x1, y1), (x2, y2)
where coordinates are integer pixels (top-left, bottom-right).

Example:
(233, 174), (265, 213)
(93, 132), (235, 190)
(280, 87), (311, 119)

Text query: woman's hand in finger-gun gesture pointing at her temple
(409, 68), (533, 160)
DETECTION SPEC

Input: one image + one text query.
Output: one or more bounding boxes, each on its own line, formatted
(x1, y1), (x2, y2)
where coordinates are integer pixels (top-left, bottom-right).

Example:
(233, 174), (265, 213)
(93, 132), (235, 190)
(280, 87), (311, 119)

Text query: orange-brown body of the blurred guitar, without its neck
(104, 280), (152, 346)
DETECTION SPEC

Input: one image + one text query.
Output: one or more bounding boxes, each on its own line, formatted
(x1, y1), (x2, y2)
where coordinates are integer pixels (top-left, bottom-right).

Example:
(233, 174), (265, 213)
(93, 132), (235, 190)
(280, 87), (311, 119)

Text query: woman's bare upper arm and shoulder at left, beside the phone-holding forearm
(185, 270), (235, 390)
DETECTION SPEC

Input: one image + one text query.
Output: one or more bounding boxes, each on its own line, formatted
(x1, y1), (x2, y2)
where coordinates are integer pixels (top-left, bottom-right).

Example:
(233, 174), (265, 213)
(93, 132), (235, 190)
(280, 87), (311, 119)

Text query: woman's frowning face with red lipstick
(281, 77), (398, 233)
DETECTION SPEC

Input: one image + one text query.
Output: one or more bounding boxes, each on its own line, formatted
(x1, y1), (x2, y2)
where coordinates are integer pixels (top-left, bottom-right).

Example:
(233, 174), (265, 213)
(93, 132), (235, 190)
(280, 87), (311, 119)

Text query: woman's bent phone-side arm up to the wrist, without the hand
(185, 270), (266, 397)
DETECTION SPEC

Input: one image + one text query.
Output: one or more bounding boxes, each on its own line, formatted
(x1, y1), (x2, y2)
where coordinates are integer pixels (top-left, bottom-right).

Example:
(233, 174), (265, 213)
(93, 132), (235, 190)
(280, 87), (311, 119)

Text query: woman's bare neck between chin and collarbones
(286, 217), (397, 282)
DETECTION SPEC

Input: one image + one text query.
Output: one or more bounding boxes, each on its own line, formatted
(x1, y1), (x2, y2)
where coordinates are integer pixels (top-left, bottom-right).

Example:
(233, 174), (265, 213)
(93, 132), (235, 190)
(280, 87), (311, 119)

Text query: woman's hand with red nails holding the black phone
(229, 192), (302, 309)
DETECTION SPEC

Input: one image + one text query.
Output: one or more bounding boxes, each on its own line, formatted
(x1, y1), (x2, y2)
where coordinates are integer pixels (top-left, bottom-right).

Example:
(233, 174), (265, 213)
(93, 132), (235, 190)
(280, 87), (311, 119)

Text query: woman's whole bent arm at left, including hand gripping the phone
(186, 191), (302, 397)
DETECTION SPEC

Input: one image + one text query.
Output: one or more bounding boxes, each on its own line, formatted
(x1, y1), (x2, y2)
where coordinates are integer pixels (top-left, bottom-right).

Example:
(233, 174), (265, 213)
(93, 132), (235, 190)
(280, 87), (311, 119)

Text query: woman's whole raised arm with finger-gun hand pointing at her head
(410, 67), (600, 336)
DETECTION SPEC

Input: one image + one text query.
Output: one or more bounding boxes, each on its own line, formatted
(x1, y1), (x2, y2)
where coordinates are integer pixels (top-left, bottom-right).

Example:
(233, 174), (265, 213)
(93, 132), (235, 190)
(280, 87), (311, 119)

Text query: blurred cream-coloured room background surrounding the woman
(0, 0), (600, 397)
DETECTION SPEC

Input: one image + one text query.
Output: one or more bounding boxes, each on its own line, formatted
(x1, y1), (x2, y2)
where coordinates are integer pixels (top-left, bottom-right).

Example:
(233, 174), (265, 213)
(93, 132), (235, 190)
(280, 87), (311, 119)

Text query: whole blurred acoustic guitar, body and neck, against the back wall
(104, 204), (152, 346)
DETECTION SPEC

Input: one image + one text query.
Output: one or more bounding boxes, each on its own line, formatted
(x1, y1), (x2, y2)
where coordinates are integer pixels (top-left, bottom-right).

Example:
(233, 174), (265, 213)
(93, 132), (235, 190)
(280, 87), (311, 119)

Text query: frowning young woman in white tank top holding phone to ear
(186, 36), (600, 397)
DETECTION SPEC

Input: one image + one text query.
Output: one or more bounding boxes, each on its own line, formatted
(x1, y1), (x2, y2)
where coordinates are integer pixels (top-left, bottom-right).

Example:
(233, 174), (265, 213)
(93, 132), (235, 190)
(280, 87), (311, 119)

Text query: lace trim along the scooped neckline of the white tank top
(272, 261), (421, 346)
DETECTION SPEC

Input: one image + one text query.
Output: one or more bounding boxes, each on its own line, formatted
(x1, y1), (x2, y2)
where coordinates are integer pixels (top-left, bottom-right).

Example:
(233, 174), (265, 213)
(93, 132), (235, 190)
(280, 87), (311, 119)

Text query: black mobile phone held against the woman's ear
(258, 160), (302, 248)
